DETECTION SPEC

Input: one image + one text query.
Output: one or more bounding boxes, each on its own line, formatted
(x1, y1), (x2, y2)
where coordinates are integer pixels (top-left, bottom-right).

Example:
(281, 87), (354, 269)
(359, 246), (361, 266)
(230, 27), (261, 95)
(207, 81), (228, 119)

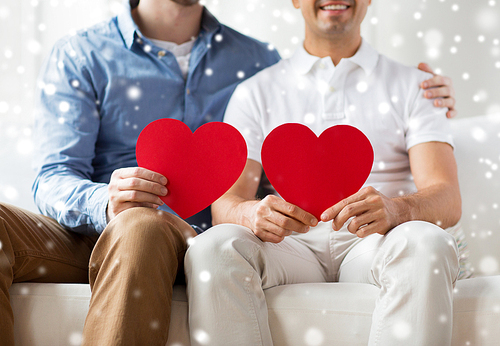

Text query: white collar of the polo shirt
(290, 39), (379, 75)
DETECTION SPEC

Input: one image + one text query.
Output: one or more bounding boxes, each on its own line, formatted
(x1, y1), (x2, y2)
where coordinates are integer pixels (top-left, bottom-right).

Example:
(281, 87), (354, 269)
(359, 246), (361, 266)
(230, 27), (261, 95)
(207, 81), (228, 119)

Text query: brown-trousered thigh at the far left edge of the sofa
(0, 204), (97, 282)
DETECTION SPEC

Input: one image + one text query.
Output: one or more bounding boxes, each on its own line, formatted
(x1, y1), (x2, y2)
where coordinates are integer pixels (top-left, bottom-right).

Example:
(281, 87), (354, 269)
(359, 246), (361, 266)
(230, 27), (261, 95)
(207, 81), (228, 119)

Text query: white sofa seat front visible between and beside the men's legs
(10, 276), (500, 346)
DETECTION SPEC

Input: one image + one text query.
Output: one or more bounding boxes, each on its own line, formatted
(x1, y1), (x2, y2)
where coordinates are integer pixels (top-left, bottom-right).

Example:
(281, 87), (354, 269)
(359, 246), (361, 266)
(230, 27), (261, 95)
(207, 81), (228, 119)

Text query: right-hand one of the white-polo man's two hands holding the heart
(321, 186), (402, 238)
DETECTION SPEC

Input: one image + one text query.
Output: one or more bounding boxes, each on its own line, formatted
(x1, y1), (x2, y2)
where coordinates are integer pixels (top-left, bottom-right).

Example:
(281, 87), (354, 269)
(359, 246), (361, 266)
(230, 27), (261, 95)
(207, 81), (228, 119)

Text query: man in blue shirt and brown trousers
(0, 0), (454, 345)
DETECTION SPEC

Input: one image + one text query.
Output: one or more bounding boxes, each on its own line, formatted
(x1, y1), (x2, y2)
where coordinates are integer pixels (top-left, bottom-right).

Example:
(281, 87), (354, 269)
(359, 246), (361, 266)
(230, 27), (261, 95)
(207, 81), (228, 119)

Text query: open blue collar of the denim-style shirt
(117, 0), (221, 49)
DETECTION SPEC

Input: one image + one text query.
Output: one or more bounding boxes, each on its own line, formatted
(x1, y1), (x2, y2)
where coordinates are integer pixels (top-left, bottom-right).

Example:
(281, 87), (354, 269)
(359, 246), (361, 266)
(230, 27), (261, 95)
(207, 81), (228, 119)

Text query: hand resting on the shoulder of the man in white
(418, 62), (457, 118)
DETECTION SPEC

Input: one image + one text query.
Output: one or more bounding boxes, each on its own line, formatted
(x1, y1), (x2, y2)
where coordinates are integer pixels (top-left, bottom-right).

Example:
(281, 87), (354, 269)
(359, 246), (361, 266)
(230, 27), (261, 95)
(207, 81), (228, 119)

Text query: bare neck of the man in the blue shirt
(132, 0), (203, 44)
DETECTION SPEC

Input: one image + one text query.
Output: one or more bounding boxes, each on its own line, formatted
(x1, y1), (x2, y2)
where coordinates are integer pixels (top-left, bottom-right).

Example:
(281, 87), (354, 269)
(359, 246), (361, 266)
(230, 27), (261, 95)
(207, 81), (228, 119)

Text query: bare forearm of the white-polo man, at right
(392, 183), (462, 228)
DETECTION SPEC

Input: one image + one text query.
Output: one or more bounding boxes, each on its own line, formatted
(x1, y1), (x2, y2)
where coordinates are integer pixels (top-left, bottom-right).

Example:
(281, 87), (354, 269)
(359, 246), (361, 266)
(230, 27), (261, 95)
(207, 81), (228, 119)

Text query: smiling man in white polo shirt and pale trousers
(186, 0), (461, 346)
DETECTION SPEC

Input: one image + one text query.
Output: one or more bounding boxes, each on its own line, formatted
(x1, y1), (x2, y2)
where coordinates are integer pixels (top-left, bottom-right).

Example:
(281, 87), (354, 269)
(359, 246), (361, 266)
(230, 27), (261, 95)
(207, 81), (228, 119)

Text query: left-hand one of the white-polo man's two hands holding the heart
(248, 195), (318, 243)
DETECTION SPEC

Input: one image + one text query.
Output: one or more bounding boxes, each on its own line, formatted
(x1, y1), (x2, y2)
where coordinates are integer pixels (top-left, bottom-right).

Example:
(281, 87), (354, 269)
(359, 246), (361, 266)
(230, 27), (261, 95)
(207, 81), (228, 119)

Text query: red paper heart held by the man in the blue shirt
(136, 119), (247, 219)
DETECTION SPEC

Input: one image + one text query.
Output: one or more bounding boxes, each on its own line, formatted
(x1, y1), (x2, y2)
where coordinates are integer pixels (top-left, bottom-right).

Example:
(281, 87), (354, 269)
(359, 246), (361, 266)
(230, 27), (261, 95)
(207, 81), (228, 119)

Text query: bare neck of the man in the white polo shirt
(304, 31), (361, 66)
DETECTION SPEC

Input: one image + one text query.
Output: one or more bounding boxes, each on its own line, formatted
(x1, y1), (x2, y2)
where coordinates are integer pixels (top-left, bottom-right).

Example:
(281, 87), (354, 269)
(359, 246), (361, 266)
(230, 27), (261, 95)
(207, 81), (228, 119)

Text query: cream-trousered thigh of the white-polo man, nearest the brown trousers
(187, 224), (328, 289)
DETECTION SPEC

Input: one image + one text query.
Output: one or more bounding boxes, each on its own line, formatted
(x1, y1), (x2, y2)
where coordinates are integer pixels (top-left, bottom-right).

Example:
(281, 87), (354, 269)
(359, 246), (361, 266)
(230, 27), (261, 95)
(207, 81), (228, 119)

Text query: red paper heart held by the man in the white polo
(261, 124), (373, 220)
